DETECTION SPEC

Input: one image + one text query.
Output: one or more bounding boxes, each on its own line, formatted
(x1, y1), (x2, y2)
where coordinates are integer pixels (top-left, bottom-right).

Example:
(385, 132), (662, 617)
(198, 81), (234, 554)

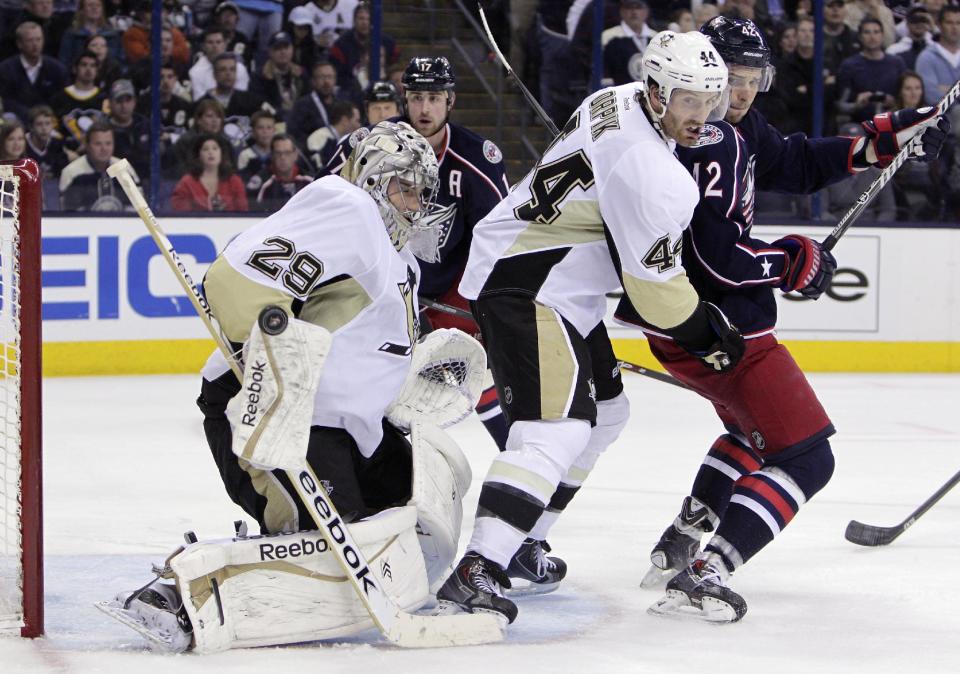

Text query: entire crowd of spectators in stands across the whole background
(0, 0), (960, 220)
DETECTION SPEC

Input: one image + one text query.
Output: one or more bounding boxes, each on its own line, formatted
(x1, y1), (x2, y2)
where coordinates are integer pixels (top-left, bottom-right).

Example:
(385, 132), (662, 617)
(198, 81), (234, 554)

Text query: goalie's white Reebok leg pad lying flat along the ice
(170, 506), (428, 653)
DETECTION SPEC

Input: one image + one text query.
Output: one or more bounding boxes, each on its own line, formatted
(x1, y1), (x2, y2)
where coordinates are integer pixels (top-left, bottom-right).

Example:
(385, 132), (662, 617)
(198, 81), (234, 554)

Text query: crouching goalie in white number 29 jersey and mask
(100, 122), (486, 652)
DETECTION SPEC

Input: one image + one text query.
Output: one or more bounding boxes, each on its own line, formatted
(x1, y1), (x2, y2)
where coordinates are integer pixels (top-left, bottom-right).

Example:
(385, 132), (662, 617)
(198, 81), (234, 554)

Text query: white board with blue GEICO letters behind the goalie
(41, 216), (251, 342)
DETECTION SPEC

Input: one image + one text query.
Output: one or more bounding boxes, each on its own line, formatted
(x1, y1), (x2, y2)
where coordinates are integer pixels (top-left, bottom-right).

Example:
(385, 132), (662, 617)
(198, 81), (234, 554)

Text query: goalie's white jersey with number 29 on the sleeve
(203, 176), (420, 456)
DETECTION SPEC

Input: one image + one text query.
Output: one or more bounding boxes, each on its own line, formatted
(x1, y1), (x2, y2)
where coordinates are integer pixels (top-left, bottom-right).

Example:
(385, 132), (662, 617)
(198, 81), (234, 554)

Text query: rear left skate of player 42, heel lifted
(640, 496), (713, 589)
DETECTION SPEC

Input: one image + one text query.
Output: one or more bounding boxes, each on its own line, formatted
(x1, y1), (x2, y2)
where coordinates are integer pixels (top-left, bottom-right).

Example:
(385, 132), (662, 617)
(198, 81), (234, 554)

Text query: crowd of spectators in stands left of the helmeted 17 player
(0, 0), (401, 212)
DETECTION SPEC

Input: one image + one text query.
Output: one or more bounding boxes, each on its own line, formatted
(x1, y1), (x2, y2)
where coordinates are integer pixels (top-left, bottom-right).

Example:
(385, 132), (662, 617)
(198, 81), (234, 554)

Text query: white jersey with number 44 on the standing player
(460, 83), (699, 336)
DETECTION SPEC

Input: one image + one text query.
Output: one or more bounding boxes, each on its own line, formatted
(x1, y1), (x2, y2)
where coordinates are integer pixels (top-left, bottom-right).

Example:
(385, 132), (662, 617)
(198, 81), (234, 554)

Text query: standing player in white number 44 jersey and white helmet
(437, 31), (743, 622)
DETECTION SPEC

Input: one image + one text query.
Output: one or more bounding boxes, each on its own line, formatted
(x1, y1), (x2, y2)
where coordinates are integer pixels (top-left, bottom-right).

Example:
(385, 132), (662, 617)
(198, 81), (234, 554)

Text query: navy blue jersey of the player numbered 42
(677, 110), (853, 337)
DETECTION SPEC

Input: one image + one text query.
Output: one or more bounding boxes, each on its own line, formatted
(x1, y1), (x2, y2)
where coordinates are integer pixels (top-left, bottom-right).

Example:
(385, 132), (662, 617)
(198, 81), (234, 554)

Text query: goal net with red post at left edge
(0, 159), (43, 637)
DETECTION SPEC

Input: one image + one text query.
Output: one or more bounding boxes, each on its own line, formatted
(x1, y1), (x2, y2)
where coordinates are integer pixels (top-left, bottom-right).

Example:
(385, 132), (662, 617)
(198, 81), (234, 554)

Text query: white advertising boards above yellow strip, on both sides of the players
(42, 217), (960, 342)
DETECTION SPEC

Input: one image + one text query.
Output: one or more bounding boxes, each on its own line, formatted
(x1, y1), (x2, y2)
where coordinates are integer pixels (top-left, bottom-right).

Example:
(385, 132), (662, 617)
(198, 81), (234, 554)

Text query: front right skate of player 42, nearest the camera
(647, 553), (747, 623)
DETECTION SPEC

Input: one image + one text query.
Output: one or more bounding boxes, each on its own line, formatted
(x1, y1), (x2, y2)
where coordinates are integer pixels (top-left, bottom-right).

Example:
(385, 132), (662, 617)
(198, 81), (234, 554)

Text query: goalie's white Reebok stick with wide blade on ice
(107, 159), (503, 648)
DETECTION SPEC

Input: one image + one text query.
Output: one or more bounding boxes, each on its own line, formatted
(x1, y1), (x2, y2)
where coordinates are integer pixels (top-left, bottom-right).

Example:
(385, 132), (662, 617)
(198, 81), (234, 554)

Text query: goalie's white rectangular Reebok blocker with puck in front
(233, 318), (331, 470)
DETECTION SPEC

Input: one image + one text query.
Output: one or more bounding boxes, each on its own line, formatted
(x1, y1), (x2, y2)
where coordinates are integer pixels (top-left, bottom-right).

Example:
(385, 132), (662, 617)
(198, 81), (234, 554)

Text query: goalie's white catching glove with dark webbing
(386, 328), (487, 431)
